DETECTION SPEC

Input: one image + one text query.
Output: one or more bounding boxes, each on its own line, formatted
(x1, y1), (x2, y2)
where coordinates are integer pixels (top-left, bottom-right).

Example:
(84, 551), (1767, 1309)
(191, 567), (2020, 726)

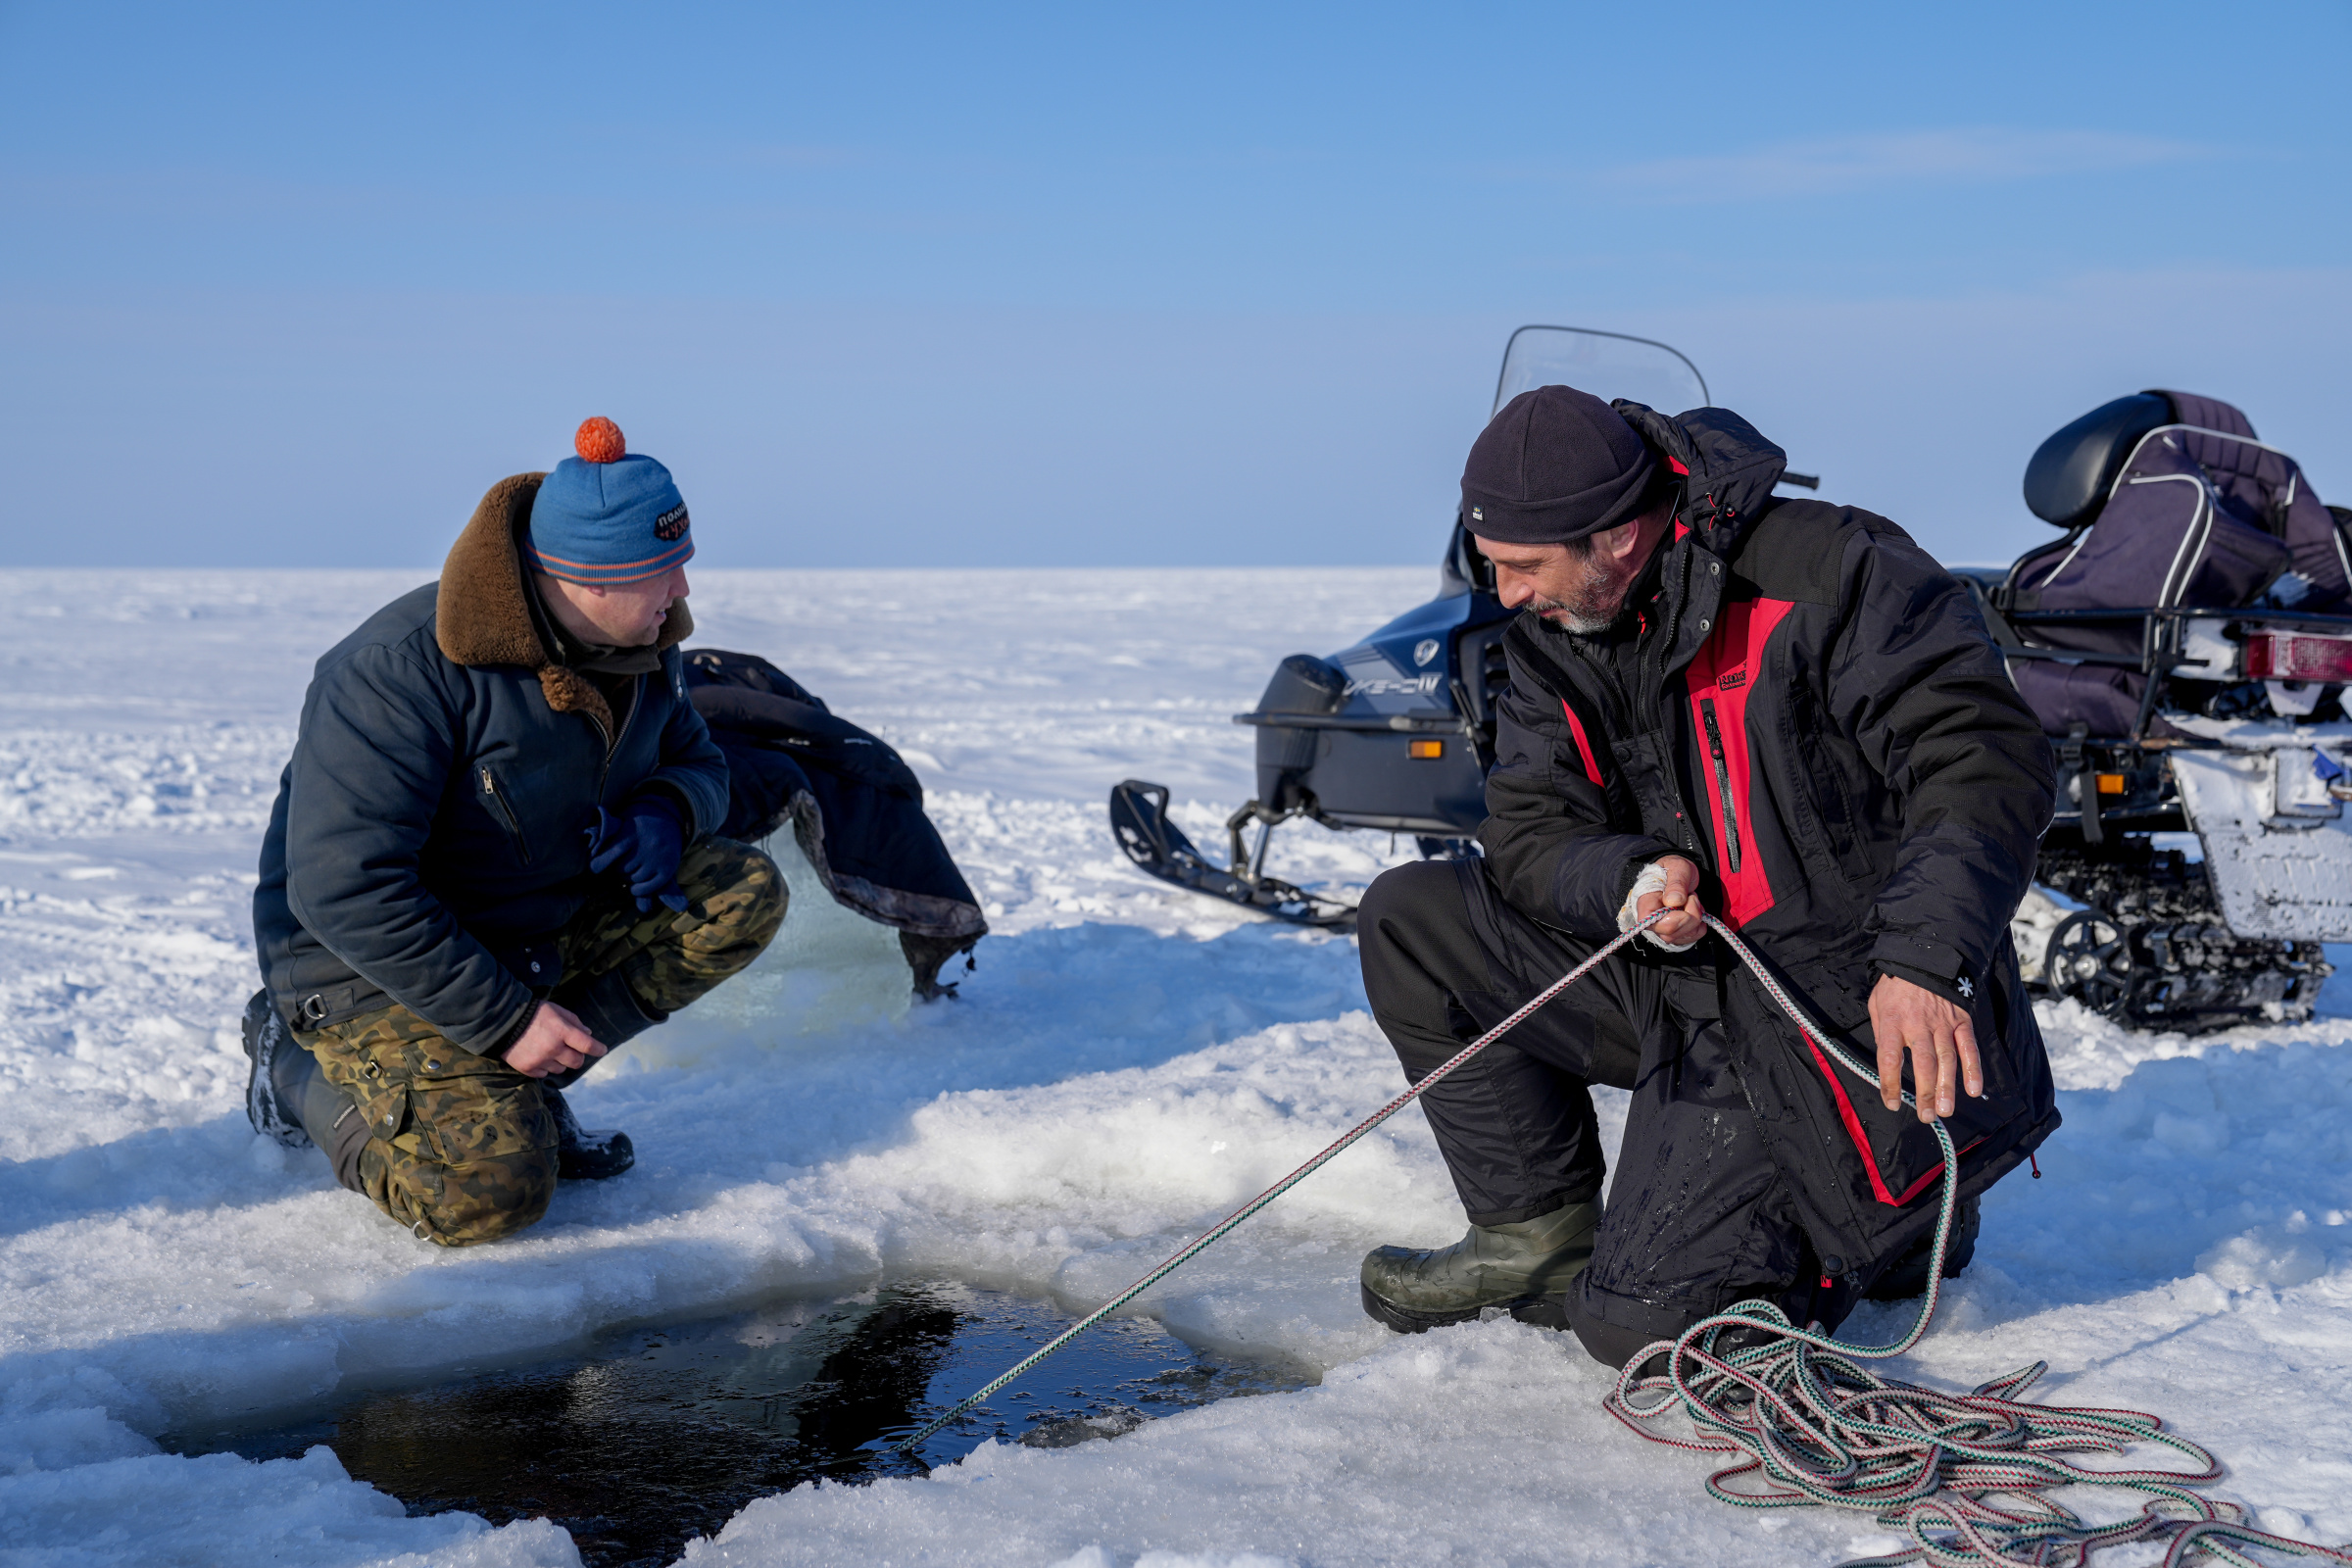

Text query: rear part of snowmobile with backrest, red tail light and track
(1959, 393), (2352, 1032)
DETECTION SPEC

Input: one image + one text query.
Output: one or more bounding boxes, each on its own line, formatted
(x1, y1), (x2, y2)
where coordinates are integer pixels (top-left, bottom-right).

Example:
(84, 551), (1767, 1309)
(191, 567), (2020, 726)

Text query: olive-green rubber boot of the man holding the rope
(1359, 1203), (1601, 1333)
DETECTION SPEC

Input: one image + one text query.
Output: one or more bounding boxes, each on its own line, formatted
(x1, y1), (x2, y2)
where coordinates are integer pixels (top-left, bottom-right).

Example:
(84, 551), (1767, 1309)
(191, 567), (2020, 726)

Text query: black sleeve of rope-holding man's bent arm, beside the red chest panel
(1477, 644), (1675, 938)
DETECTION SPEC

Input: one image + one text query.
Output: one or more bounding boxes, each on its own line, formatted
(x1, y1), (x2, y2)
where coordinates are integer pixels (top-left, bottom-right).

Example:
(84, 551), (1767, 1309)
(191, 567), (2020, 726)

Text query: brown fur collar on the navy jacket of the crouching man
(435, 472), (694, 736)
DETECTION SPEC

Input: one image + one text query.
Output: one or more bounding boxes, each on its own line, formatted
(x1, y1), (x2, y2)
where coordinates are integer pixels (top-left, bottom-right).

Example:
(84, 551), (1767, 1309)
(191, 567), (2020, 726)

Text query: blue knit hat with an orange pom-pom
(536, 418), (694, 583)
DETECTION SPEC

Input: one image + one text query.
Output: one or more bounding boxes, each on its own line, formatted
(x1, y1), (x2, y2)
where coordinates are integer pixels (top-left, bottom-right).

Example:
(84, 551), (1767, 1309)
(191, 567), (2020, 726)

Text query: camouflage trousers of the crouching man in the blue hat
(294, 837), (786, 1246)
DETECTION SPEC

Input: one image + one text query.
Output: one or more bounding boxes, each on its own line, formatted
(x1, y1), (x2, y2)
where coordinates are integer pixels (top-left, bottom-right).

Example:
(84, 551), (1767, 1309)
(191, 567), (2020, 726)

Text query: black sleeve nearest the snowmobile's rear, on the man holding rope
(1828, 531), (2056, 980)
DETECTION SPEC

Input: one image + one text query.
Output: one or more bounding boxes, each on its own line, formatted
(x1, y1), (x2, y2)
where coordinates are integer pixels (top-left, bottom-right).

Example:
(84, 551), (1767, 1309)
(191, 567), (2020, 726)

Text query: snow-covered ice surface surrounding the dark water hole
(0, 569), (2352, 1568)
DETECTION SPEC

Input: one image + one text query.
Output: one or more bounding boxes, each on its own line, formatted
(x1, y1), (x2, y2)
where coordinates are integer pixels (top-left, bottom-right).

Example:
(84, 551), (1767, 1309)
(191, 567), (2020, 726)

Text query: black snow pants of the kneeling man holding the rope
(1357, 860), (1856, 1366)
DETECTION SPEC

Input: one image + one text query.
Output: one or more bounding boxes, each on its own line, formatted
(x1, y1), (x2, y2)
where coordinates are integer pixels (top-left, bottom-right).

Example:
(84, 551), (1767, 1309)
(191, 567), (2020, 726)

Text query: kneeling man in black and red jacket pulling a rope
(1357, 385), (2058, 1366)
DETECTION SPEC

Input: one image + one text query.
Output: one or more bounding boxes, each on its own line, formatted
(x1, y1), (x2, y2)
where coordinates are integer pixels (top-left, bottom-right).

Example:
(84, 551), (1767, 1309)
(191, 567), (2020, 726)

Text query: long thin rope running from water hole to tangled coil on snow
(896, 909), (2352, 1568)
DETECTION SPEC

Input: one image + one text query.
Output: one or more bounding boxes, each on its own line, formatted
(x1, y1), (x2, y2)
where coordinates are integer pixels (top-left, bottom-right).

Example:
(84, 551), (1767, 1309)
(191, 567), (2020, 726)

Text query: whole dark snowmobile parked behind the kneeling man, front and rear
(1110, 340), (2352, 1032)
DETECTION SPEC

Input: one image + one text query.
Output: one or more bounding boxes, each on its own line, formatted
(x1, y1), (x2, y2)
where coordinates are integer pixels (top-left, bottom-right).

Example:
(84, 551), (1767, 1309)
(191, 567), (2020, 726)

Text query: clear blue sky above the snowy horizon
(0, 2), (2352, 569)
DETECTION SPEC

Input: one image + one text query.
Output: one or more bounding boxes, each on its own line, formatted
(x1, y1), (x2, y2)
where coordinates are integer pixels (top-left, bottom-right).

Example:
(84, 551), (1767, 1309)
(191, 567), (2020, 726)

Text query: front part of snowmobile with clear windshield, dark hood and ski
(1110, 326), (1818, 931)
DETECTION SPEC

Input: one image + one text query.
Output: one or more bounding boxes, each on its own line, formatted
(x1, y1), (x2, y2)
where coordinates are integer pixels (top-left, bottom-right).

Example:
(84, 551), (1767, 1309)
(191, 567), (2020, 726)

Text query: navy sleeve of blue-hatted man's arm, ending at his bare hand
(287, 644), (538, 1051)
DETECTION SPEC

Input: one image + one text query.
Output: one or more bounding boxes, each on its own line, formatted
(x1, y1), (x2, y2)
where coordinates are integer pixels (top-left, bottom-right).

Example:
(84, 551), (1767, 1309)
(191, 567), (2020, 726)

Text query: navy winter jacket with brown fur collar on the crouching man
(254, 475), (727, 1051)
